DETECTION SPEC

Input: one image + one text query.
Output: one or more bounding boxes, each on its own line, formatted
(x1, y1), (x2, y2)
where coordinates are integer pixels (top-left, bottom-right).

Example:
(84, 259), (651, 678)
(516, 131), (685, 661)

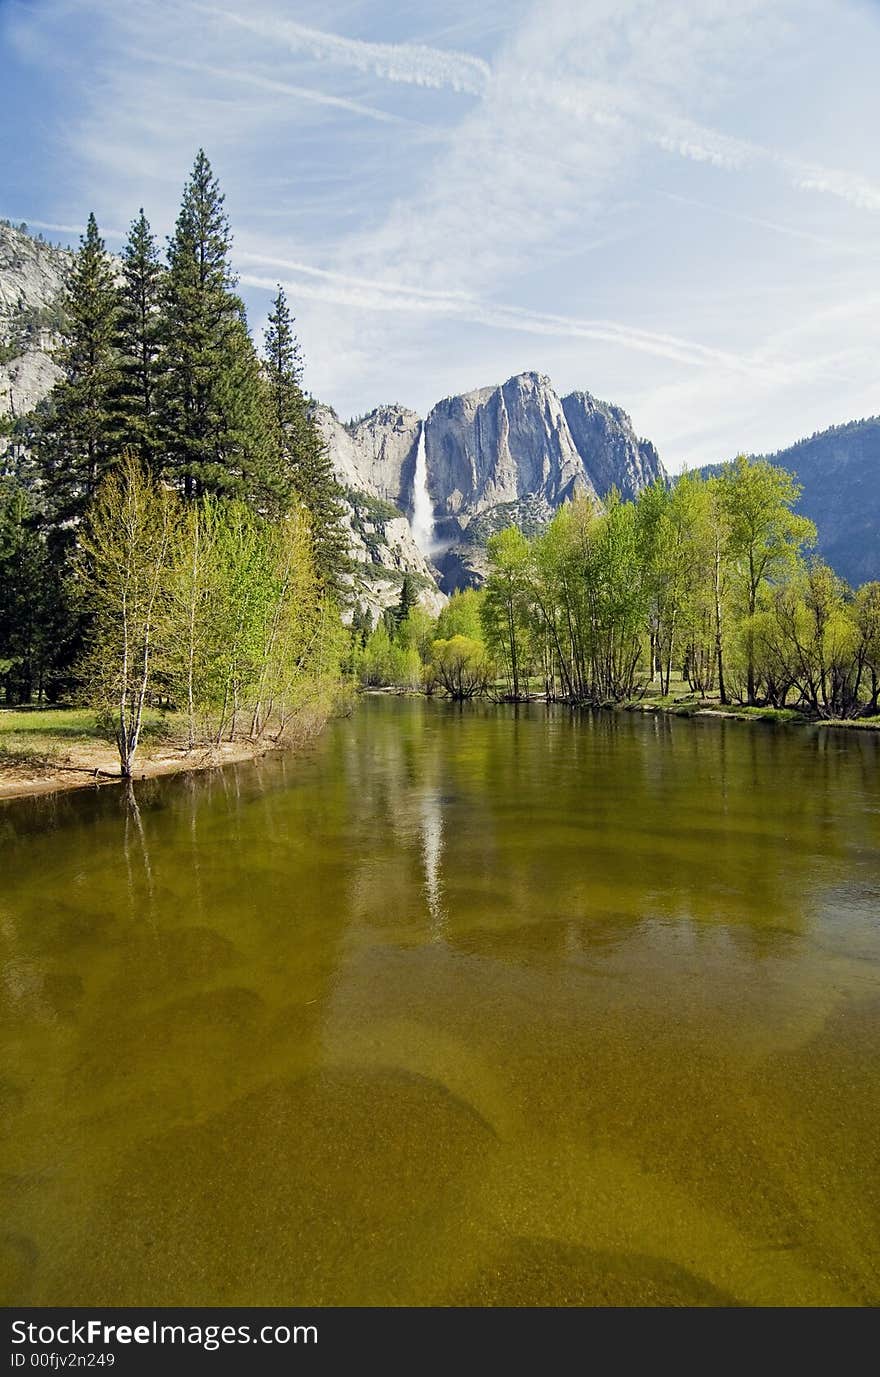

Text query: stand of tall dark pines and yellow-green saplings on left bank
(0, 151), (350, 774)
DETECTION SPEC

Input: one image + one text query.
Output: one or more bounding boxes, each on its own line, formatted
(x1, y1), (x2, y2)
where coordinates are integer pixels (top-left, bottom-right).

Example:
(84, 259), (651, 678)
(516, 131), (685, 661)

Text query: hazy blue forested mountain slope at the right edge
(700, 416), (880, 588)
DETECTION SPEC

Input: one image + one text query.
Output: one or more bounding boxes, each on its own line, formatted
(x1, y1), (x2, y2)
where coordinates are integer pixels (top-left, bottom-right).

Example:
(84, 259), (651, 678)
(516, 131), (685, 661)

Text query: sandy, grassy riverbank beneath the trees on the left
(0, 708), (333, 801)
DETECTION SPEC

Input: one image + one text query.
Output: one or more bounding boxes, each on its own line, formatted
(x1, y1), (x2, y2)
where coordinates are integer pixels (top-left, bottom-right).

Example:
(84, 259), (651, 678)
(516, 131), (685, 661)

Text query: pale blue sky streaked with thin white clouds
(0, 0), (880, 471)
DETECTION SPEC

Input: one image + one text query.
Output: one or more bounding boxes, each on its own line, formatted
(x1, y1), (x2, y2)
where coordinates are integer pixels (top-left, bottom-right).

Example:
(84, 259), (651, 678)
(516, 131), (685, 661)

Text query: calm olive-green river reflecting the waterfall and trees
(0, 698), (880, 1304)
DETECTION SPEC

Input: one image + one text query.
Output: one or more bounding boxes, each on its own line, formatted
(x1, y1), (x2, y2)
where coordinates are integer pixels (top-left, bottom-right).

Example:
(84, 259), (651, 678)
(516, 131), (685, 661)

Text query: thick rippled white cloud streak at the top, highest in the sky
(194, 6), (492, 95)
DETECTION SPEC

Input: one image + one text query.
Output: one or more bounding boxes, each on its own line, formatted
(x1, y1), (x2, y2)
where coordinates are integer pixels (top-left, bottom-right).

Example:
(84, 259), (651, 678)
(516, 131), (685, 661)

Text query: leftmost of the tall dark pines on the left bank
(34, 215), (120, 525)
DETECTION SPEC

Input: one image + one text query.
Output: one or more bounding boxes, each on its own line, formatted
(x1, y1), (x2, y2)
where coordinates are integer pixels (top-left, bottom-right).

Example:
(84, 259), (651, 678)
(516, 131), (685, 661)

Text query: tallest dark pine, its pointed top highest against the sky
(160, 149), (271, 508)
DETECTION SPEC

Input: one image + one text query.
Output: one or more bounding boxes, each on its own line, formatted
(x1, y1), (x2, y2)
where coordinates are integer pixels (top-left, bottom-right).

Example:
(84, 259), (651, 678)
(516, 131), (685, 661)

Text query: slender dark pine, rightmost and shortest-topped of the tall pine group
(263, 286), (348, 593)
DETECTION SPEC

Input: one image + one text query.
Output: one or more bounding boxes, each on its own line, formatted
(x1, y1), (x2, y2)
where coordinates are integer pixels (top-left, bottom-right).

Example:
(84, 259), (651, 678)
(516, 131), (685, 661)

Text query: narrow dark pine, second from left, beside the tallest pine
(116, 208), (163, 470)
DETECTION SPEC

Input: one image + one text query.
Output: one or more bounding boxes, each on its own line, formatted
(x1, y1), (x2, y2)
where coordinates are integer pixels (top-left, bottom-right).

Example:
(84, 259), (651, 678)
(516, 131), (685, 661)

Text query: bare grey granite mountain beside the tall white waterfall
(315, 373), (665, 592)
